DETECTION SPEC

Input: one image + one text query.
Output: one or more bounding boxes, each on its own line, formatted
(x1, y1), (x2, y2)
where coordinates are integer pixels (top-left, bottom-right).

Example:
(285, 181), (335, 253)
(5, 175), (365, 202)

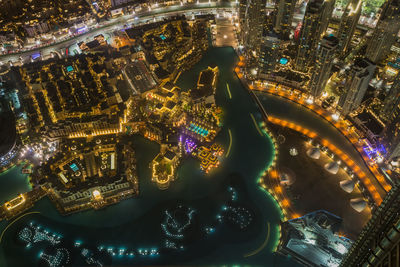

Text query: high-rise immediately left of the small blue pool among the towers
(258, 32), (281, 77)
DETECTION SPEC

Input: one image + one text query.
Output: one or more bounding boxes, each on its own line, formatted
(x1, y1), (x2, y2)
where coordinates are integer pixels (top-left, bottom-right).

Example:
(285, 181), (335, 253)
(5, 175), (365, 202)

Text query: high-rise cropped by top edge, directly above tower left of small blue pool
(274, 0), (296, 39)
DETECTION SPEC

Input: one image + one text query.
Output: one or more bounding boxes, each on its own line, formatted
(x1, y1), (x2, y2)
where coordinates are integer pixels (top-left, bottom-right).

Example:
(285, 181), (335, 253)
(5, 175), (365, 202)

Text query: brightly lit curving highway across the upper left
(0, 2), (235, 65)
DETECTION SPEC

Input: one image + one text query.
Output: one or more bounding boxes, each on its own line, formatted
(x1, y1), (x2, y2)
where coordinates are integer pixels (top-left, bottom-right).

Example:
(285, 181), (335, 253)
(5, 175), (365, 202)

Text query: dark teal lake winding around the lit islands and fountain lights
(0, 48), (296, 267)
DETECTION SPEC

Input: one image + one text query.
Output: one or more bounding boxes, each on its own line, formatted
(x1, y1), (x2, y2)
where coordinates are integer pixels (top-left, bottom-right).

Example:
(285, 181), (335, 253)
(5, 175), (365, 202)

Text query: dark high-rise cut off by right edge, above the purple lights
(380, 73), (400, 122)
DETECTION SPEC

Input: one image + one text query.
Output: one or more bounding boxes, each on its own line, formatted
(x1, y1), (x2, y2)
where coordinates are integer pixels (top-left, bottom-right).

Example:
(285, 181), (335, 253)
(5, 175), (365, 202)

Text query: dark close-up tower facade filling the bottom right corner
(340, 185), (400, 267)
